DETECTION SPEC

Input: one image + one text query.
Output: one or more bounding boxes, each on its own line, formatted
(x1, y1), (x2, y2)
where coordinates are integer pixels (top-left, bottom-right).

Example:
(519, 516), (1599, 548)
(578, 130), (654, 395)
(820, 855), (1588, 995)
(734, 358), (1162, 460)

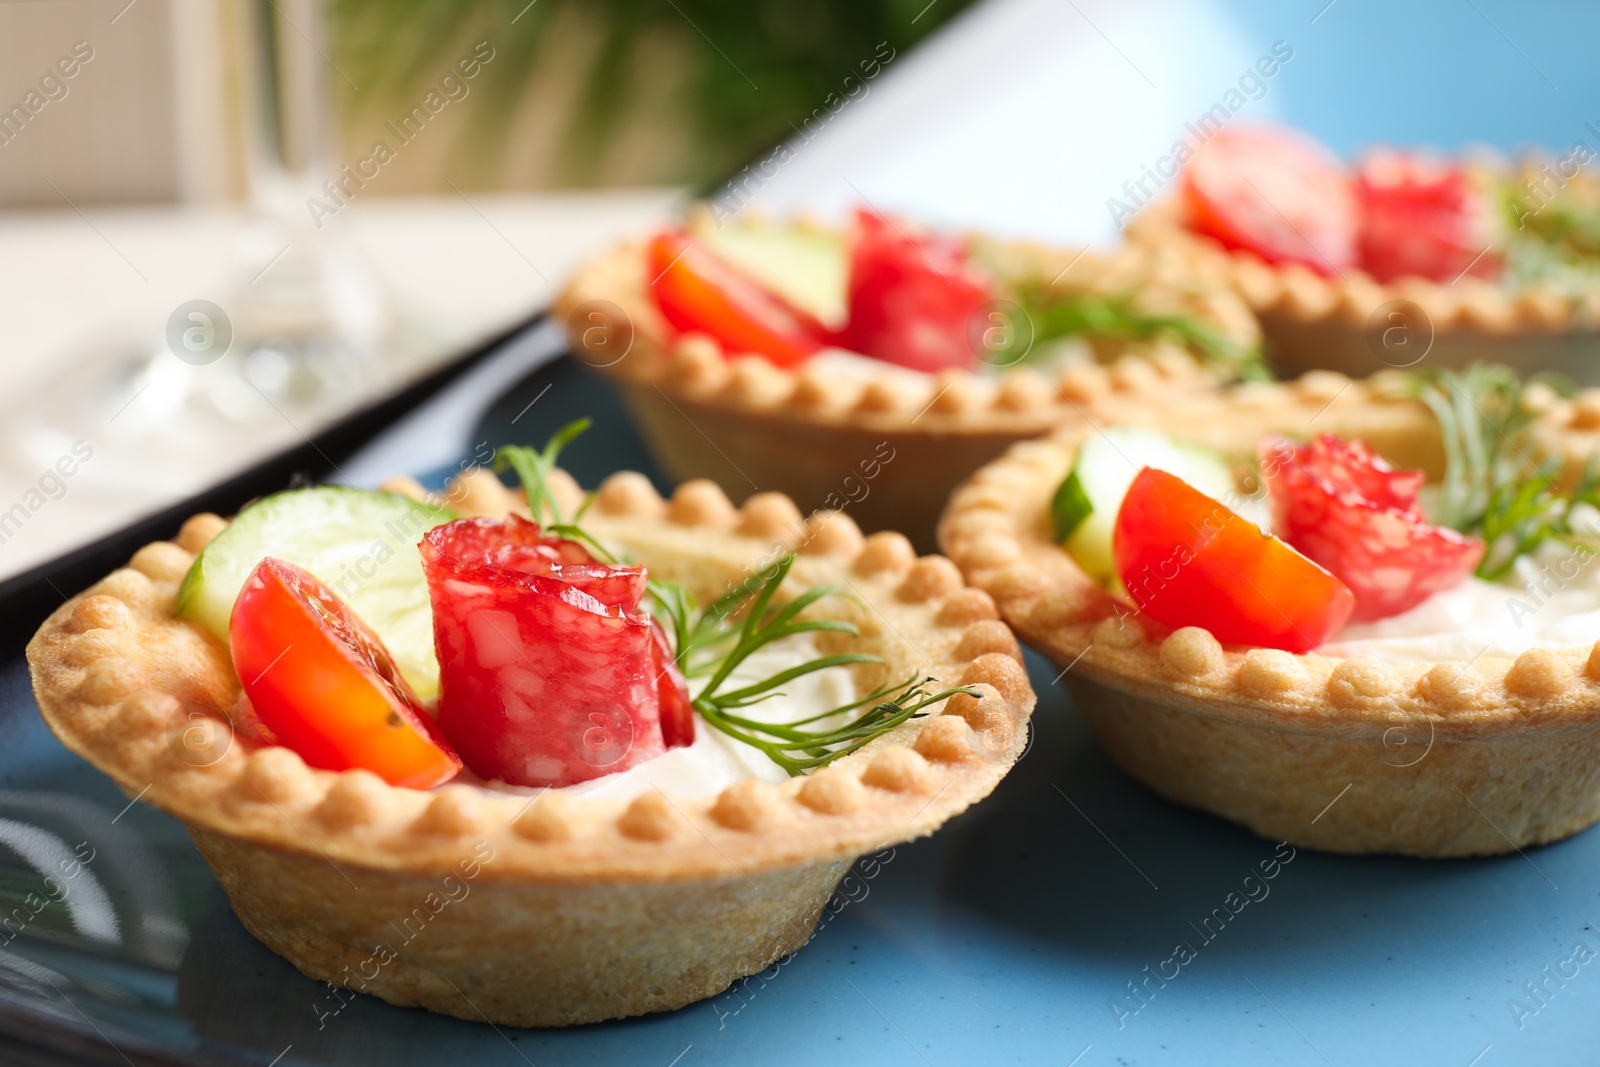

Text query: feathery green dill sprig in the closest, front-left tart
(496, 419), (976, 774)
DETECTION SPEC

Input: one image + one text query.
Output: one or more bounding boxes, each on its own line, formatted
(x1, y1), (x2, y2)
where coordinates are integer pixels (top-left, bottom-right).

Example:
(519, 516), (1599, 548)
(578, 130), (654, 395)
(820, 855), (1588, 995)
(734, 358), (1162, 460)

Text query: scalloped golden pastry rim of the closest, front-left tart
(27, 472), (1035, 885)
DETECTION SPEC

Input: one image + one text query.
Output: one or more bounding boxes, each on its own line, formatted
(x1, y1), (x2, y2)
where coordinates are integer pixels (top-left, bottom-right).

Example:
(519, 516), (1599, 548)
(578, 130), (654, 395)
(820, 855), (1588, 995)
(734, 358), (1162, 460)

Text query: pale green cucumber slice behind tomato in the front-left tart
(178, 485), (454, 701)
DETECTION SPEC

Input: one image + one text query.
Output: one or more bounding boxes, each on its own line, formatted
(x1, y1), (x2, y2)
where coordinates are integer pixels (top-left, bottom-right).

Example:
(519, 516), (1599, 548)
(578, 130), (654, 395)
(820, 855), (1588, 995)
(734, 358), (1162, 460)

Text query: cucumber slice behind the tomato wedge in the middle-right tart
(1051, 427), (1238, 584)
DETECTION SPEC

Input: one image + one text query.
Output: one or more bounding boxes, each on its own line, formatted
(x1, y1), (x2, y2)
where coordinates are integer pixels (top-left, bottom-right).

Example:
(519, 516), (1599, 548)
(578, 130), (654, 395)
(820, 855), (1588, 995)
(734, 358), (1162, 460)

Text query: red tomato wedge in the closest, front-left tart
(227, 557), (461, 789)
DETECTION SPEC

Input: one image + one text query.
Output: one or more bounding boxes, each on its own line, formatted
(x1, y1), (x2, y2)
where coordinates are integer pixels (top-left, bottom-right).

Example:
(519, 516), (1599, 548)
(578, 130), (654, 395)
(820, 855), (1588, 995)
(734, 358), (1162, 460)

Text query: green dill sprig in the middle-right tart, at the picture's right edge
(1405, 365), (1600, 581)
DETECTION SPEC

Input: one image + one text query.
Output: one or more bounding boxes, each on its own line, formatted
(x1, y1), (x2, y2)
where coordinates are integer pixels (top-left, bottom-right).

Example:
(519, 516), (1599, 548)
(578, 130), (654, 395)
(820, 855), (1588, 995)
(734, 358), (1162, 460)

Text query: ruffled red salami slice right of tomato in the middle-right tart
(1261, 434), (1483, 622)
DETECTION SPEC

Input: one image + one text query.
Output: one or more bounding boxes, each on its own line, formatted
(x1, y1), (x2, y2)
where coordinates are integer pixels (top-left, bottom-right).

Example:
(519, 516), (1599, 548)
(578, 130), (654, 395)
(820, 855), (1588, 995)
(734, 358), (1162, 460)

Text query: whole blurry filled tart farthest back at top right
(1128, 126), (1600, 384)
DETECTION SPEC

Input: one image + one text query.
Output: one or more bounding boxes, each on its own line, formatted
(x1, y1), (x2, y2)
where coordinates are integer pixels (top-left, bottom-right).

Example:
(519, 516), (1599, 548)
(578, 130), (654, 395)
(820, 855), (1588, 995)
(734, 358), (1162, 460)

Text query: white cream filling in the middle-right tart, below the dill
(1317, 544), (1600, 664)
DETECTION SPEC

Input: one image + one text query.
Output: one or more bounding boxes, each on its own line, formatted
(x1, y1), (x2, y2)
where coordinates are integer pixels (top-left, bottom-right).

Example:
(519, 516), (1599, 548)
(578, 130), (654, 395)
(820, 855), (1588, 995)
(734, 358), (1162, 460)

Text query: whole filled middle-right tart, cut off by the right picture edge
(939, 368), (1600, 856)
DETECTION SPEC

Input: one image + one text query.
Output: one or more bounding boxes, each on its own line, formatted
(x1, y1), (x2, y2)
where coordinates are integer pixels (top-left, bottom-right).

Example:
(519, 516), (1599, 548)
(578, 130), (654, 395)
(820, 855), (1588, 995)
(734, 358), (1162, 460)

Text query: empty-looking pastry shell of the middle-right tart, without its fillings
(939, 373), (1600, 856)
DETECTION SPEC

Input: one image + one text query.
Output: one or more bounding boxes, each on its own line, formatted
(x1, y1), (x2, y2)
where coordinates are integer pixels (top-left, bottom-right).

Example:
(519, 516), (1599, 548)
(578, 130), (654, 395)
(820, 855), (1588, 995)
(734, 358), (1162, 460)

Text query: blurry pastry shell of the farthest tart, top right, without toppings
(1128, 200), (1600, 386)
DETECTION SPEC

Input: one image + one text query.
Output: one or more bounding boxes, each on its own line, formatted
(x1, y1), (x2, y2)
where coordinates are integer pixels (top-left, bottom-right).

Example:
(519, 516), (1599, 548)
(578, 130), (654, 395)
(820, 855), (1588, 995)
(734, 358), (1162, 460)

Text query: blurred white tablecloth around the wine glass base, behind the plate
(0, 190), (675, 579)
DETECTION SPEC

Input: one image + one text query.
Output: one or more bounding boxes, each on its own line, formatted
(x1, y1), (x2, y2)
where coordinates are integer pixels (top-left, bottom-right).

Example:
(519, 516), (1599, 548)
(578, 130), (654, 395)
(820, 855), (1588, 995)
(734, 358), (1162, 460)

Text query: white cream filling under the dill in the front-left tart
(456, 633), (856, 800)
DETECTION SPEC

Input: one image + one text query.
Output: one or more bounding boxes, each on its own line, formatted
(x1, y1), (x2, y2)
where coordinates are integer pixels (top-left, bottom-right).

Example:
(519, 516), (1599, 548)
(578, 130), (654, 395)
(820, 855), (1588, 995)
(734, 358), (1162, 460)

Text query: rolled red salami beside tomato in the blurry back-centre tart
(835, 211), (994, 373)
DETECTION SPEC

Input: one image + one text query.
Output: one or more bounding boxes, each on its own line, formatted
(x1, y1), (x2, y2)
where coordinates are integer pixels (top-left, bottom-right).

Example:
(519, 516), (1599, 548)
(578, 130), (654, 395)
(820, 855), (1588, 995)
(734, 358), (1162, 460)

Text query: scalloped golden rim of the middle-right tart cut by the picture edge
(939, 371), (1600, 741)
